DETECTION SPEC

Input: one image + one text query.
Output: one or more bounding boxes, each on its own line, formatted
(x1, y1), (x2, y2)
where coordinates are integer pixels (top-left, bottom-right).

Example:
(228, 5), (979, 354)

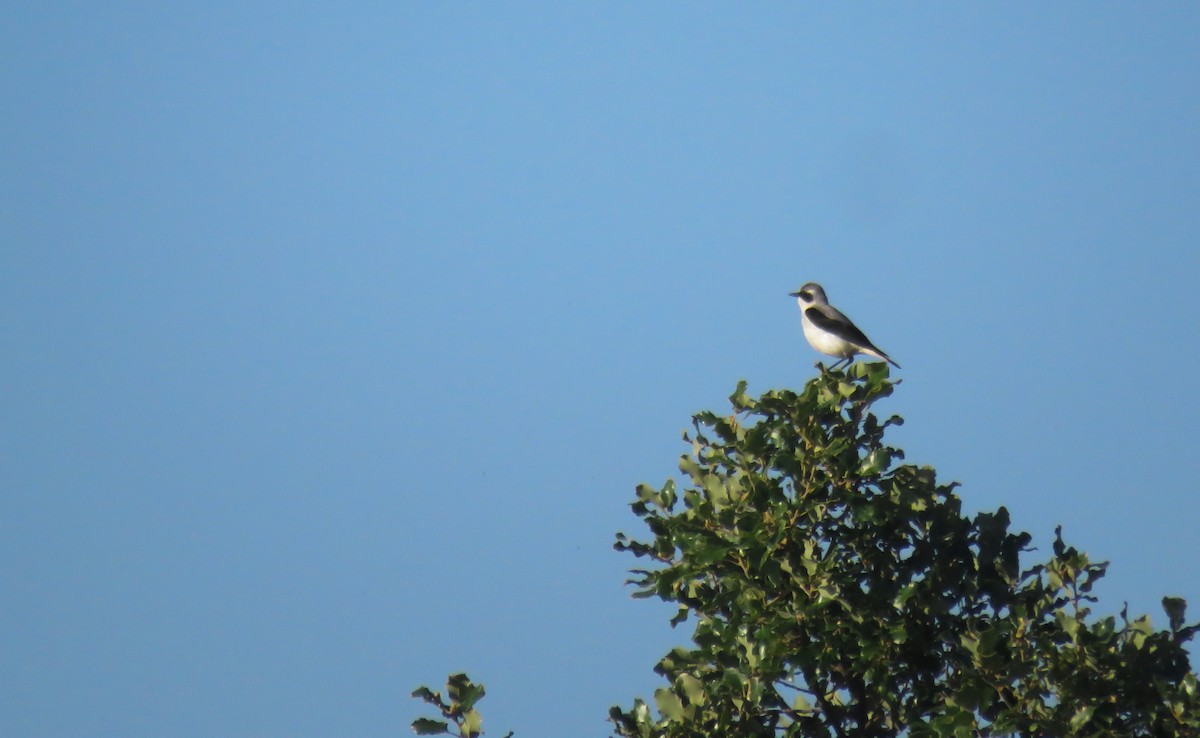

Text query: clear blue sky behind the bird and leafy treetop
(0, 1), (1200, 738)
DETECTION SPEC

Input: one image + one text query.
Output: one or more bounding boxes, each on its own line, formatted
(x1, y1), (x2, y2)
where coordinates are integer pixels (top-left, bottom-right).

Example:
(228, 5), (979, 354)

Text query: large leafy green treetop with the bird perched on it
(610, 364), (1200, 738)
